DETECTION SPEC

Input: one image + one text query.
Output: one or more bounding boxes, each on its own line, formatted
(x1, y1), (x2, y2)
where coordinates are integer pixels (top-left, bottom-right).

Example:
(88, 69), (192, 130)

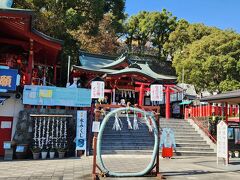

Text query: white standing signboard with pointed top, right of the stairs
(217, 121), (228, 165)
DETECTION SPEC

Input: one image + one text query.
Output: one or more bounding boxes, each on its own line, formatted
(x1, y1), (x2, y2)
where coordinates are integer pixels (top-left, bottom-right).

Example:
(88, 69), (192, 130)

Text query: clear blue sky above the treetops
(125, 0), (240, 33)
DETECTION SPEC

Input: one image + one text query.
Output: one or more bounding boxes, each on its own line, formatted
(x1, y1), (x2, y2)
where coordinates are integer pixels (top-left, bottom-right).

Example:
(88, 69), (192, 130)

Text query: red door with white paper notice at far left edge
(0, 116), (13, 156)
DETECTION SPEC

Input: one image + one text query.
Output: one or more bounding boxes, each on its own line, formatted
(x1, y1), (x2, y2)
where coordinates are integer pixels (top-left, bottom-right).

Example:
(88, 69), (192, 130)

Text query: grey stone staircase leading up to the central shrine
(99, 116), (215, 156)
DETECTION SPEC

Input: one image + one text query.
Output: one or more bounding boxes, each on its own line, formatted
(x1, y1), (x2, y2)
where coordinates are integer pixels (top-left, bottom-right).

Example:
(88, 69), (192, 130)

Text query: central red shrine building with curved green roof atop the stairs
(72, 52), (183, 119)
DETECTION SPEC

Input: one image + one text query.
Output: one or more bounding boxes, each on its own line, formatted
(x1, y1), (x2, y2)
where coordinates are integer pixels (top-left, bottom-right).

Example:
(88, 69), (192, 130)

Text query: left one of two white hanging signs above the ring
(91, 81), (105, 99)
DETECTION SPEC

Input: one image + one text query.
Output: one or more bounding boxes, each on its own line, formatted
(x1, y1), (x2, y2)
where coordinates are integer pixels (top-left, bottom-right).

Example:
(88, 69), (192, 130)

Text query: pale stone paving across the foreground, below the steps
(0, 155), (240, 180)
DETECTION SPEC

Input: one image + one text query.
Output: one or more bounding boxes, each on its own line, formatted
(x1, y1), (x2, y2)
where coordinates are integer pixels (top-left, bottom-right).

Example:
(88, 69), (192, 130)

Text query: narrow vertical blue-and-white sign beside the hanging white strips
(76, 111), (87, 151)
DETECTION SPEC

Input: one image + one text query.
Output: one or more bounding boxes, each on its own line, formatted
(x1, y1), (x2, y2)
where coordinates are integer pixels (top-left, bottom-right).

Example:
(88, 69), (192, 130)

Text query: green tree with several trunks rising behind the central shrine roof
(125, 9), (176, 57)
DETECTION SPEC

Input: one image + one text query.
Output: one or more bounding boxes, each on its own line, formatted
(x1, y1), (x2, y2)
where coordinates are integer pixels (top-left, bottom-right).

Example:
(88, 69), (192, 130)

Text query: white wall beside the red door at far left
(0, 94), (24, 139)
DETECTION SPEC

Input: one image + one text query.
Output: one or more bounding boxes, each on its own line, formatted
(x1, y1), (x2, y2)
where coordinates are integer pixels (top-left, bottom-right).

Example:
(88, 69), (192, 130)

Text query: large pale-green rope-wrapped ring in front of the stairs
(97, 107), (159, 177)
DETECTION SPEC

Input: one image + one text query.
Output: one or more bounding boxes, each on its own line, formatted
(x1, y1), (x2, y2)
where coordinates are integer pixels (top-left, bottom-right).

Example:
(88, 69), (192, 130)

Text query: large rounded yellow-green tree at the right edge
(173, 28), (240, 92)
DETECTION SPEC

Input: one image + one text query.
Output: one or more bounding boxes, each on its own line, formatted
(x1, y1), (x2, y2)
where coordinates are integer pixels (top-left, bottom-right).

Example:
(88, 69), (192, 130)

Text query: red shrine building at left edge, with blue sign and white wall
(0, 7), (63, 156)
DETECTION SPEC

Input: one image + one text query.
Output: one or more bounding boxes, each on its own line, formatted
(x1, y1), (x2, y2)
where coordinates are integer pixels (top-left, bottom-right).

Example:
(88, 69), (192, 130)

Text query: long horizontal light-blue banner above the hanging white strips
(23, 85), (91, 107)
